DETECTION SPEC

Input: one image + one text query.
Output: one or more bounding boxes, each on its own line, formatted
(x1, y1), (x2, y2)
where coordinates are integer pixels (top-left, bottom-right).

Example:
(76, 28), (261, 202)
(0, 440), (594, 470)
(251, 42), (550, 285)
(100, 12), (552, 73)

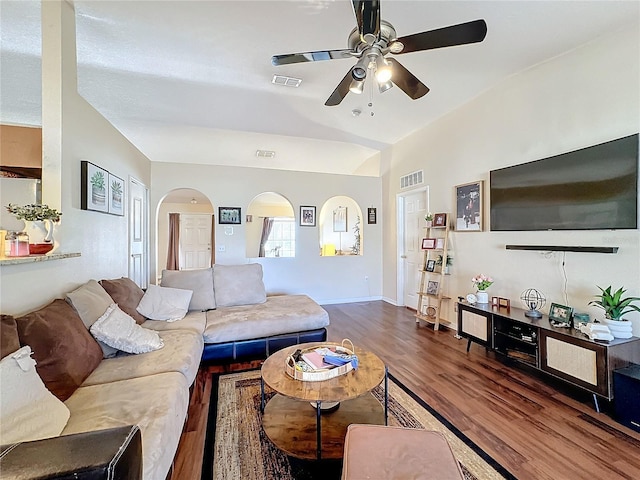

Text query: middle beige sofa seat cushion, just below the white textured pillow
(82, 330), (204, 387)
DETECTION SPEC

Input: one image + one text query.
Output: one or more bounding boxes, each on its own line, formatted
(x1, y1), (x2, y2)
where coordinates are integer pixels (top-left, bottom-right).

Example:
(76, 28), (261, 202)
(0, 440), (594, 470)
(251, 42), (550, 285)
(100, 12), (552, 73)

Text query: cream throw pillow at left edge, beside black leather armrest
(0, 346), (70, 445)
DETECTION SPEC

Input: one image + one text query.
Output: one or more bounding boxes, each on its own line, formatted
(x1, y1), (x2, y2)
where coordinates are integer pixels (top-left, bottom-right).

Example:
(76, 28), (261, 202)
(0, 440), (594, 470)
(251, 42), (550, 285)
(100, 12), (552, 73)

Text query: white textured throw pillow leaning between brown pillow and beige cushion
(91, 303), (164, 353)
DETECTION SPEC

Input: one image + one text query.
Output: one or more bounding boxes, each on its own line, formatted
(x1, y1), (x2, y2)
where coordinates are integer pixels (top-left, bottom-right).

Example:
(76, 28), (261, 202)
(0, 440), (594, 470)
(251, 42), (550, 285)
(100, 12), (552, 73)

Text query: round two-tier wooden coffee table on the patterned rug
(261, 342), (388, 460)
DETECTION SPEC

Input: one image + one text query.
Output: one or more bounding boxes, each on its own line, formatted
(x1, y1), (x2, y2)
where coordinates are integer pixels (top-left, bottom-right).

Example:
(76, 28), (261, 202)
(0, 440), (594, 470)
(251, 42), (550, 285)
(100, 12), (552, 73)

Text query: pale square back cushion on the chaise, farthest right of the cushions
(213, 263), (267, 307)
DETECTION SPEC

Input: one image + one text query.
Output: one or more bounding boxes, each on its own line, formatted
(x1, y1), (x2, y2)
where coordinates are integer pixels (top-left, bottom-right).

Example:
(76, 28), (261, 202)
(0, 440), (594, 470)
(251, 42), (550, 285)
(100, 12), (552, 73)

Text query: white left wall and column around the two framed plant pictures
(0, 2), (150, 315)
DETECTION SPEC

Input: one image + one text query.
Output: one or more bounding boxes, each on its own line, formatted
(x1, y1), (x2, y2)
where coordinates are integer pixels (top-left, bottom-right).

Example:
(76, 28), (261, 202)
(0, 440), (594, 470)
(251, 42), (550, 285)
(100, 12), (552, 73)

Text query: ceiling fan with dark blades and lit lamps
(271, 0), (487, 106)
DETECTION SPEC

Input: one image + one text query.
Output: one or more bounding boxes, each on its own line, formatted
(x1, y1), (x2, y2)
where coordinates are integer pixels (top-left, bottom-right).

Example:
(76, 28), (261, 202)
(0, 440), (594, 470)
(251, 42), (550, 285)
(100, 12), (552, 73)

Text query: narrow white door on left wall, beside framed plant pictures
(129, 178), (149, 288)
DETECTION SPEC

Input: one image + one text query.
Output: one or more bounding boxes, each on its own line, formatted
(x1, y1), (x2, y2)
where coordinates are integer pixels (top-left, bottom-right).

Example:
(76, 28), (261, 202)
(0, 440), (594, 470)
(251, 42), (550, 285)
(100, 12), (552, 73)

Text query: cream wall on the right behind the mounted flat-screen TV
(383, 27), (640, 335)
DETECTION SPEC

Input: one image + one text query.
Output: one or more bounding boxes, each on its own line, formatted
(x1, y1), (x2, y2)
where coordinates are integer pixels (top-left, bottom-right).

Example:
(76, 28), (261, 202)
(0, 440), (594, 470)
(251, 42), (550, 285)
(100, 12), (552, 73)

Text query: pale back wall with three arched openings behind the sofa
(150, 163), (384, 303)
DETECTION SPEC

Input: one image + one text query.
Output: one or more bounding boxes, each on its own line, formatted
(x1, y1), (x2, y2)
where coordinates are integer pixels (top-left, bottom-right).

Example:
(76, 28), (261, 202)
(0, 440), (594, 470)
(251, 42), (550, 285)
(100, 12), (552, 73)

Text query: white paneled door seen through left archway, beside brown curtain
(180, 213), (212, 270)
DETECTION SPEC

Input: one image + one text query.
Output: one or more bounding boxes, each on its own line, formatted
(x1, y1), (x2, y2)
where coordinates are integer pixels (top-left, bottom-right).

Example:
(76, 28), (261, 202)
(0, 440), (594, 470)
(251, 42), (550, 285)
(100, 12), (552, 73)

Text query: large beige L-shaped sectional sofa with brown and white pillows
(0, 264), (329, 480)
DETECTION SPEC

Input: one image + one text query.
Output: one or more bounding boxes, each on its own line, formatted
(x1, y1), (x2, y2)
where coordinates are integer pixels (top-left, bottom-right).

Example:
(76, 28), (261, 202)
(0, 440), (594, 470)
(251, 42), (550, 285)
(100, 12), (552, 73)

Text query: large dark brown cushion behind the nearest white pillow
(16, 299), (102, 402)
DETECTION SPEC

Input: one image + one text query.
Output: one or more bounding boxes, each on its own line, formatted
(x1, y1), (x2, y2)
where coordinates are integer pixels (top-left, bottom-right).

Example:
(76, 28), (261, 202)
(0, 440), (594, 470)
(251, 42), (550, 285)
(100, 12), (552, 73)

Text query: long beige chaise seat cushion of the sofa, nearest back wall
(204, 295), (329, 343)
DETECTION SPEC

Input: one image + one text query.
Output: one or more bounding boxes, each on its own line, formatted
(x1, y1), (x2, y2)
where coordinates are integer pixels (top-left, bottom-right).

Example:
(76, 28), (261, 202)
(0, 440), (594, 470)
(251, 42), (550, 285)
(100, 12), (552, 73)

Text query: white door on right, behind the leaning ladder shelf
(402, 190), (427, 308)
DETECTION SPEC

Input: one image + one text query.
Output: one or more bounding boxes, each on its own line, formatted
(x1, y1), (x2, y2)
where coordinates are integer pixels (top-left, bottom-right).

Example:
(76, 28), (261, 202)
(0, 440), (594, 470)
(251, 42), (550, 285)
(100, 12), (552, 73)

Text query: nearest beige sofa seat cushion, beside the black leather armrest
(62, 372), (189, 480)
